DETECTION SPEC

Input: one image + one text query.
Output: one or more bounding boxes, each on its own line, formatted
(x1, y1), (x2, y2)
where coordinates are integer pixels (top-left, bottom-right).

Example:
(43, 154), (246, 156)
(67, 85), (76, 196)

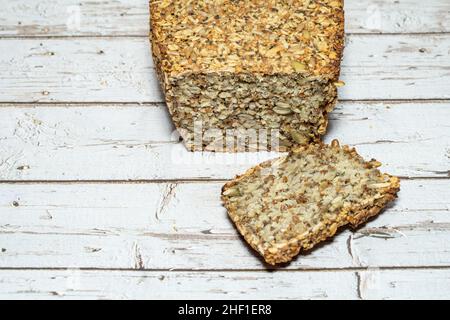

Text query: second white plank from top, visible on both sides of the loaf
(0, 34), (450, 102)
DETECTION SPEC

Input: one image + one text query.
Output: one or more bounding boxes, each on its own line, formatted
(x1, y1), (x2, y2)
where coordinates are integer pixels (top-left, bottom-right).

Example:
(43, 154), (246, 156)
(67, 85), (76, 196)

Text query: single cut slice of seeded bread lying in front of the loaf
(222, 140), (400, 265)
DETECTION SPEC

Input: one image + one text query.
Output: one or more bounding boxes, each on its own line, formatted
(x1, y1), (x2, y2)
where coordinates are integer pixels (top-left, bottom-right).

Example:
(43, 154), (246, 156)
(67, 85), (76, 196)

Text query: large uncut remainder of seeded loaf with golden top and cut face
(150, 0), (344, 152)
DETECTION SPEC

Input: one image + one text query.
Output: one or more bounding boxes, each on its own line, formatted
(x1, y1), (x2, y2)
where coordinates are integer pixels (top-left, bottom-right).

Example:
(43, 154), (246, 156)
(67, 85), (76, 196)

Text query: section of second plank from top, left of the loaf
(0, 38), (163, 102)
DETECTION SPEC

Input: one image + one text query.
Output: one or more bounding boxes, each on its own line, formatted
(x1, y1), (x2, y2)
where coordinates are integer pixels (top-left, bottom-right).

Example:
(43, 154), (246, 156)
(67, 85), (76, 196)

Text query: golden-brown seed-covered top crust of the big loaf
(150, 0), (344, 80)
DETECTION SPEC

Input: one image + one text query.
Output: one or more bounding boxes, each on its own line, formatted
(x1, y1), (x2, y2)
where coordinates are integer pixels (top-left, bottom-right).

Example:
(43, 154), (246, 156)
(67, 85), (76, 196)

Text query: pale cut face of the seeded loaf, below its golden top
(166, 73), (337, 152)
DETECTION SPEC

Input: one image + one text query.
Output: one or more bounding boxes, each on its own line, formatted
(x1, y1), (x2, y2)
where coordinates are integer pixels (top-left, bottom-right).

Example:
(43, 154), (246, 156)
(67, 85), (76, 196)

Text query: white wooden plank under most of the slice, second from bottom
(0, 179), (450, 270)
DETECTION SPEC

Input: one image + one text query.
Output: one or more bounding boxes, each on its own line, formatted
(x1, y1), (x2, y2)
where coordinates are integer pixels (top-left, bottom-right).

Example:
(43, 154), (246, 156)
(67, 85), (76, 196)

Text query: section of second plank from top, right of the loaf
(340, 35), (450, 100)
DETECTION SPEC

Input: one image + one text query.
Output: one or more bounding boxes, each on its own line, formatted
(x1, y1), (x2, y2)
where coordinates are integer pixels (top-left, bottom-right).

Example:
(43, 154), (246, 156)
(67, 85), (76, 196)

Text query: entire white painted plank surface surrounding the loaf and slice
(0, 0), (450, 299)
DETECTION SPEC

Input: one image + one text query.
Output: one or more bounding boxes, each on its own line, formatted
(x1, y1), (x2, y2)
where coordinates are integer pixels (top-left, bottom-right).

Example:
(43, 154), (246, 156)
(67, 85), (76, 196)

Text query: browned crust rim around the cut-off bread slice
(222, 140), (400, 265)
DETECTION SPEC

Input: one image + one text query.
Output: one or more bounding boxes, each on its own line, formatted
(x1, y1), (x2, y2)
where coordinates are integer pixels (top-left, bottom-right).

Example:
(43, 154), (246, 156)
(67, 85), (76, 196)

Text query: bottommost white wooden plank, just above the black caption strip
(0, 269), (450, 300)
